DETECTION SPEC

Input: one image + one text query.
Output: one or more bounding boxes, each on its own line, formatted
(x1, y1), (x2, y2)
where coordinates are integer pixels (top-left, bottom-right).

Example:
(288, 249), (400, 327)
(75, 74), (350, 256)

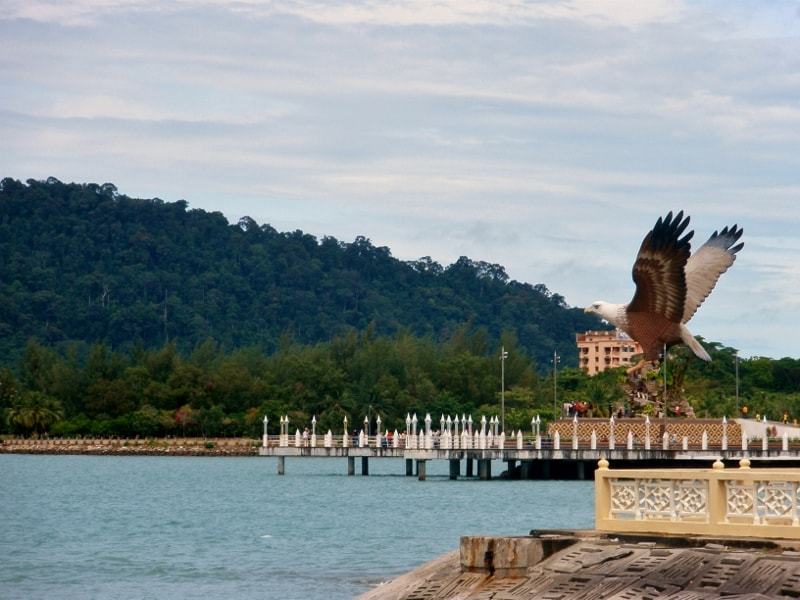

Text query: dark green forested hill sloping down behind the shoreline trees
(0, 178), (600, 366)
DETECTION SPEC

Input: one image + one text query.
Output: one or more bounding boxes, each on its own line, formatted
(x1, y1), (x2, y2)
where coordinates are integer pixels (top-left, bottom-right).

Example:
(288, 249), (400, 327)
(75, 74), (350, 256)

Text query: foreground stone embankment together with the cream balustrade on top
(361, 459), (800, 600)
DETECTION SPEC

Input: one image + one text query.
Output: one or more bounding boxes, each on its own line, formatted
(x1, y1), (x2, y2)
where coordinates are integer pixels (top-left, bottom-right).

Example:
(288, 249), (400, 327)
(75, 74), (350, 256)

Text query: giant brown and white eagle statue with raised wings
(586, 211), (744, 373)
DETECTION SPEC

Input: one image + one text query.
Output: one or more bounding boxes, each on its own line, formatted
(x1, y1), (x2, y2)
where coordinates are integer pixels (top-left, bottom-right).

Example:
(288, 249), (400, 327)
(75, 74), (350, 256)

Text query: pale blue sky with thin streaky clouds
(0, 0), (800, 357)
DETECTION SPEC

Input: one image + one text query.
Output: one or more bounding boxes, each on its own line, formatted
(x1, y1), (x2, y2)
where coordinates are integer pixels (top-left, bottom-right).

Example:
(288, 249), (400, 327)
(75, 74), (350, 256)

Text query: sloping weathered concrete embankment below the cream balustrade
(360, 531), (800, 600)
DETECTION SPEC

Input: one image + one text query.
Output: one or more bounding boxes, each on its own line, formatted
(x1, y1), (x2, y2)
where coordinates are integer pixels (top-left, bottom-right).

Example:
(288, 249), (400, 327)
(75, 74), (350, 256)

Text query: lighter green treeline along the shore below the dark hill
(0, 327), (800, 437)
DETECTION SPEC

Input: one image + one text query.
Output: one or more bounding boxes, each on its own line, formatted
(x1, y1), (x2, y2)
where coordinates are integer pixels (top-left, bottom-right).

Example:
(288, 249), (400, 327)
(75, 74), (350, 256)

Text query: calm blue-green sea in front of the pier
(0, 455), (594, 600)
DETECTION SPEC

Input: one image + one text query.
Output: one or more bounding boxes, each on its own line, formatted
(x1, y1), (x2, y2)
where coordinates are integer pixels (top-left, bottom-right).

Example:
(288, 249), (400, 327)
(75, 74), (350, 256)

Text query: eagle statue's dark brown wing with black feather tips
(627, 211), (692, 323)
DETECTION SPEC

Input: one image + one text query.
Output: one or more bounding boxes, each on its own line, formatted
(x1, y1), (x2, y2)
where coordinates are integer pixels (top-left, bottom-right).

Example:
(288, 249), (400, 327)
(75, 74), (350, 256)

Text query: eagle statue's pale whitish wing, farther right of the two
(681, 225), (744, 323)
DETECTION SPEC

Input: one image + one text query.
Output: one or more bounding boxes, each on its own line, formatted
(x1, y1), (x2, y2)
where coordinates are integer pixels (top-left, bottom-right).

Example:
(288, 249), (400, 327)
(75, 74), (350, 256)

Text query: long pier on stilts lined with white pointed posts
(258, 416), (800, 480)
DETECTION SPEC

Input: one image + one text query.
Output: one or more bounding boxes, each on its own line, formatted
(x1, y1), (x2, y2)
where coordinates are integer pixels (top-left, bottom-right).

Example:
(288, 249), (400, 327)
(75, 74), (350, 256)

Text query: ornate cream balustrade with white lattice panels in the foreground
(595, 459), (800, 539)
